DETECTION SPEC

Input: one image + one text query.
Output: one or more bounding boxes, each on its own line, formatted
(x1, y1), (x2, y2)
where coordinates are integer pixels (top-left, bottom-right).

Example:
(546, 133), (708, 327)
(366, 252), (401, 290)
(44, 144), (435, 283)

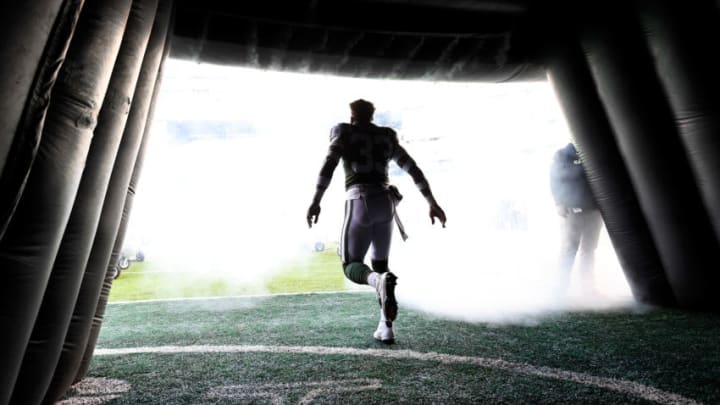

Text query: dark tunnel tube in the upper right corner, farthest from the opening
(640, 0), (720, 243)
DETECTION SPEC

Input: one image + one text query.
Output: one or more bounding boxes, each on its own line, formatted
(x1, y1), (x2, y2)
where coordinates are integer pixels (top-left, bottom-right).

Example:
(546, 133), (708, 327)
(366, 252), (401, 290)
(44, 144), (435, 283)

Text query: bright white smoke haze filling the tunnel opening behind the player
(126, 60), (631, 321)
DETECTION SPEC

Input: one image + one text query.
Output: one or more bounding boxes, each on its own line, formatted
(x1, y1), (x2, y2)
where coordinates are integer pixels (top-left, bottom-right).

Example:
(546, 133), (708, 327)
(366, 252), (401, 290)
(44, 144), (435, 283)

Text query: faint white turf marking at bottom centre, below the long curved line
(206, 378), (382, 405)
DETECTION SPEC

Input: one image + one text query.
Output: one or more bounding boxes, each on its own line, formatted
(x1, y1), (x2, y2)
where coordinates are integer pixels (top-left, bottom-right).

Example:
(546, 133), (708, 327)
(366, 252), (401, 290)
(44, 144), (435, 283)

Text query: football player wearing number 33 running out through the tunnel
(307, 99), (446, 343)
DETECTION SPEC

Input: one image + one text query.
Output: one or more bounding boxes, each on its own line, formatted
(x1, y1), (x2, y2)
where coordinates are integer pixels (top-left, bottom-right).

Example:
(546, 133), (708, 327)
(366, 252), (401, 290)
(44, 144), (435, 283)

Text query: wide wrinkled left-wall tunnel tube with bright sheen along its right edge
(0, 2), (129, 403)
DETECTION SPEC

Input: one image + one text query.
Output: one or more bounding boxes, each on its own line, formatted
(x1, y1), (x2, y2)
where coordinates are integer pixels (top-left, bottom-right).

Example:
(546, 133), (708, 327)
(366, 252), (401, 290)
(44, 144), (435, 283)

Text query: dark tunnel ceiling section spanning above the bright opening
(171, 0), (545, 82)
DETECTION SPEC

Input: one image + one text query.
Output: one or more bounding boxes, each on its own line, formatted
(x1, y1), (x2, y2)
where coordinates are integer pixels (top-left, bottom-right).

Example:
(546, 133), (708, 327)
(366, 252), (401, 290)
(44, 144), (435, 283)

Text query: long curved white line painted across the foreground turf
(95, 345), (700, 405)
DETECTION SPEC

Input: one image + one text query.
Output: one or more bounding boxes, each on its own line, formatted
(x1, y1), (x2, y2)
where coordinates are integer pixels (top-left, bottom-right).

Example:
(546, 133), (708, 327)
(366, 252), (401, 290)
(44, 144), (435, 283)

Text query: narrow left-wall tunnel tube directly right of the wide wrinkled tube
(12, 0), (158, 404)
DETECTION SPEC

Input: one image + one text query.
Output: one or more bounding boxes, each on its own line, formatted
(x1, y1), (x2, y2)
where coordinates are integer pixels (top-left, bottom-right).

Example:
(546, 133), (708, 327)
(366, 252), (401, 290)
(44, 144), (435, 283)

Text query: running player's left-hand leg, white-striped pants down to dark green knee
(340, 199), (372, 284)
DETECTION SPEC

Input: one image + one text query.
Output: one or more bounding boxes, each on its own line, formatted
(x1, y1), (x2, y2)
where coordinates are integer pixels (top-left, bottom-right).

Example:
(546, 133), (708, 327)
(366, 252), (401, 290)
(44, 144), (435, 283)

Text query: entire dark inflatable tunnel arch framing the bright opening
(0, 0), (720, 404)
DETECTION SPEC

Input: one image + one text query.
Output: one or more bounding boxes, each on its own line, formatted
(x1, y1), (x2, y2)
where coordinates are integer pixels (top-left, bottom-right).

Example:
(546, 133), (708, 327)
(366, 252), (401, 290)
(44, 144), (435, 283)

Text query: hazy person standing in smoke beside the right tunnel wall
(550, 143), (602, 293)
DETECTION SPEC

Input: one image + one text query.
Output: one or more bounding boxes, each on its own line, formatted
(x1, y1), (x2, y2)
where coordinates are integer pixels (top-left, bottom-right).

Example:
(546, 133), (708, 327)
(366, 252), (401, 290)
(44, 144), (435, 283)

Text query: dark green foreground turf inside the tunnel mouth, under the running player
(64, 293), (720, 404)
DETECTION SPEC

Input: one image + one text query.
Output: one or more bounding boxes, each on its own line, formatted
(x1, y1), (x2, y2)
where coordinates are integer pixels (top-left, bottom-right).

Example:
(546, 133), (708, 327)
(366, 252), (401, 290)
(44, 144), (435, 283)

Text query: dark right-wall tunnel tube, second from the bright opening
(581, 1), (720, 308)
